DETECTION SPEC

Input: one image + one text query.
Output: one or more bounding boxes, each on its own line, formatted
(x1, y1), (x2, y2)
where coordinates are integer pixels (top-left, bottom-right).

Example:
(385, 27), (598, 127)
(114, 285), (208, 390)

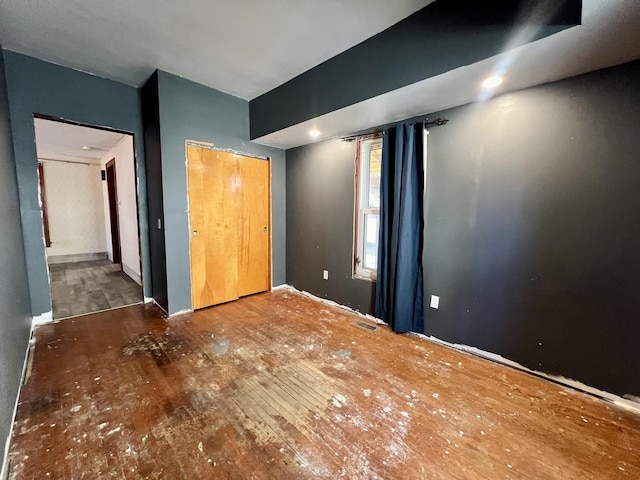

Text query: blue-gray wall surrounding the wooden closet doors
(158, 71), (285, 314)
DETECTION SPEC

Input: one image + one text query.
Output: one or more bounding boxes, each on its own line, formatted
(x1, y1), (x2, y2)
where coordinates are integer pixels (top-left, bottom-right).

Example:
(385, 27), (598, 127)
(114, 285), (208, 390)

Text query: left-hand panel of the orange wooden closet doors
(187, 145), (239, 309)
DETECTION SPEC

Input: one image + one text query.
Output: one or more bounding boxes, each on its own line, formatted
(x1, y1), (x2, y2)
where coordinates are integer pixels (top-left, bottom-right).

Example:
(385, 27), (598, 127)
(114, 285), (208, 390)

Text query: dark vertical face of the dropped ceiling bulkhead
(250, 0), (582, 138)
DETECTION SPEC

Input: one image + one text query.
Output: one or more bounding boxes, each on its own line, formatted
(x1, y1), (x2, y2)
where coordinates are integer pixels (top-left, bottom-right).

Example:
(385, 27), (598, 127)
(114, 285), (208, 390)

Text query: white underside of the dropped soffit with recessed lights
(255, 0), (640, 148)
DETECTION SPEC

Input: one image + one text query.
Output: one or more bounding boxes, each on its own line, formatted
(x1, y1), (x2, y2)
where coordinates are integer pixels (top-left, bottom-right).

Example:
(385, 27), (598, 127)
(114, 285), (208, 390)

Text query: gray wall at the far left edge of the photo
(0, 50), (31, 465)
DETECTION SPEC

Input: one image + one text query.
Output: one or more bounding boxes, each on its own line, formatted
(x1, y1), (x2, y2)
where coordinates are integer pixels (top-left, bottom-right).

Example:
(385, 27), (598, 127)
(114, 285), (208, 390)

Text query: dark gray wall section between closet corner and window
(287, 140), (375, 313)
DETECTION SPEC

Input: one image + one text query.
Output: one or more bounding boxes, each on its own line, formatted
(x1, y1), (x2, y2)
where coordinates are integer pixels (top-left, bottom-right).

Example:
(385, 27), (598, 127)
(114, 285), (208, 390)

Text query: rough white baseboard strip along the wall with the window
(284, 285), (640, 414)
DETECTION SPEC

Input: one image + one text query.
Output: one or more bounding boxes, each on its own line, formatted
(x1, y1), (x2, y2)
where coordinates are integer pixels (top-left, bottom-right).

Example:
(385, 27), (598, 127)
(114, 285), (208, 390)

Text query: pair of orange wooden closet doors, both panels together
(187, 145), (271, 310)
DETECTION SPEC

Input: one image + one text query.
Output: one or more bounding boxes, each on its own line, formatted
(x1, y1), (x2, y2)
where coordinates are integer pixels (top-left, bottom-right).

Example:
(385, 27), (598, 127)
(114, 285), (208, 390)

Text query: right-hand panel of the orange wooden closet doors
(236, 155), (271, 297)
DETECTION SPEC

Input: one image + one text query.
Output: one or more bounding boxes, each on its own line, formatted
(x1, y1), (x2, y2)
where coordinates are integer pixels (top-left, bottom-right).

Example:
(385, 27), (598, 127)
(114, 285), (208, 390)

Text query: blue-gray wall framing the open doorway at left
(4, 51), (151, 316)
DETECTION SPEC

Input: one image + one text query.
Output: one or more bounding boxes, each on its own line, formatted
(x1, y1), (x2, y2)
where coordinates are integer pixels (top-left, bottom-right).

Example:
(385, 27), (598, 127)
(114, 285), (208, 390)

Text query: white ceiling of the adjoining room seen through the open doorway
(34, 118), (125, 161)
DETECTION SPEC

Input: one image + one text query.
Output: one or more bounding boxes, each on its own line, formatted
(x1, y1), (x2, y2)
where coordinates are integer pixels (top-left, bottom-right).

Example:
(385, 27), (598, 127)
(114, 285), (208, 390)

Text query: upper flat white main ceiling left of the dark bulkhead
(0, 0), (433, 100)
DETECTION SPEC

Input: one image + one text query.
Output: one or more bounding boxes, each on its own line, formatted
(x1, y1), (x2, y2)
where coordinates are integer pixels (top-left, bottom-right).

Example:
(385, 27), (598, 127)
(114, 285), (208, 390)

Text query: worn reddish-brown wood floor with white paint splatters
(9, 291), (640, 480)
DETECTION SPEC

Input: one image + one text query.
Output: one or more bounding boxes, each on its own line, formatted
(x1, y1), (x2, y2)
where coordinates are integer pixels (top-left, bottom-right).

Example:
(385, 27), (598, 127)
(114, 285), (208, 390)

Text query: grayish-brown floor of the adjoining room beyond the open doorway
(49, 259), (142, 320)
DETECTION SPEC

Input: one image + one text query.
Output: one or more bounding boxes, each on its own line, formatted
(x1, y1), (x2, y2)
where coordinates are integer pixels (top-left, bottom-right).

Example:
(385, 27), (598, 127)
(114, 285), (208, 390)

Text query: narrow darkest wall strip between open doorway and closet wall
(141, 72), (169, 311)
